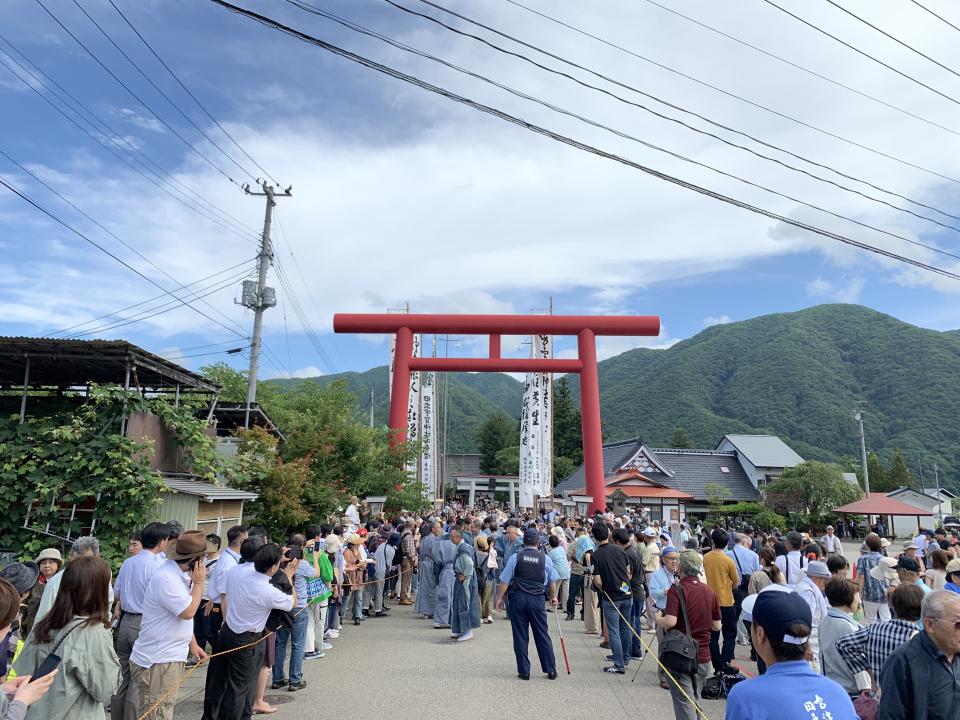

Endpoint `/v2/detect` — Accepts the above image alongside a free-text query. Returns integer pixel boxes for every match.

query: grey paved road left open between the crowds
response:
[177,605,755,720]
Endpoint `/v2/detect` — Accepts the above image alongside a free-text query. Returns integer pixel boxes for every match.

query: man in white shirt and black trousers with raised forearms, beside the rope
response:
[203,543,300,720]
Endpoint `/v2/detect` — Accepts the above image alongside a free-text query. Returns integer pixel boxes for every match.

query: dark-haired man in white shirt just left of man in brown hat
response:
[110,522,170,720]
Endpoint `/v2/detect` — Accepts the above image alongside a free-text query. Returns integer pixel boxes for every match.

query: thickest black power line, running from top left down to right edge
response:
[210,0,960,280]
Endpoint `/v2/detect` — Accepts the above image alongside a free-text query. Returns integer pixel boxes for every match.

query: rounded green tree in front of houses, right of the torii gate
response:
[764,460,862,525]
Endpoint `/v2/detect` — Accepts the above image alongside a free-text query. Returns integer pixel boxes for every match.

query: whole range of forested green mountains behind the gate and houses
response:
[270,305,960,488]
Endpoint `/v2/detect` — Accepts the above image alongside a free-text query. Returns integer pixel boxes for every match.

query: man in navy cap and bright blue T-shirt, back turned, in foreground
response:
[726,592,857,720]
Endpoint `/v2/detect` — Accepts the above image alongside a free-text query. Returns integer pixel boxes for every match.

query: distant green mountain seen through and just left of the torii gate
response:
[269,365,523,453]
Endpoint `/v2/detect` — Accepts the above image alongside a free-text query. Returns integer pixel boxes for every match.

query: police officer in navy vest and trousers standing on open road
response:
[497,528,560,680]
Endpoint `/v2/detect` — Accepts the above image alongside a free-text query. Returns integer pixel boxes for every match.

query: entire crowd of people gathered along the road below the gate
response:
[0,498,960,720]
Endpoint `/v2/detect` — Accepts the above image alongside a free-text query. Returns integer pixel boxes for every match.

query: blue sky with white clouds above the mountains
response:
[0,0,960,377]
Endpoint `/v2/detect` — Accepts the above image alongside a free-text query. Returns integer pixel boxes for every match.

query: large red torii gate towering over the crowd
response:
[333,313,660,511]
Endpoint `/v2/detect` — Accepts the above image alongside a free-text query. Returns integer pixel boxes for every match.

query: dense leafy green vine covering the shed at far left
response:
[0,387,169,566]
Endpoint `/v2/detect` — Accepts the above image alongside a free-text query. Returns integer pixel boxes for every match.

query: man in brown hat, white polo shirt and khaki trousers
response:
[130,526,207,720]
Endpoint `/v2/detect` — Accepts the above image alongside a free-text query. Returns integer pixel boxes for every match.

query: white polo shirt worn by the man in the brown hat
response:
[130,560,193,668]
